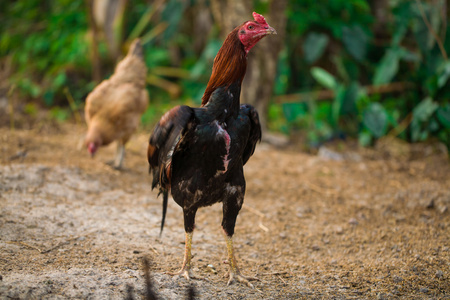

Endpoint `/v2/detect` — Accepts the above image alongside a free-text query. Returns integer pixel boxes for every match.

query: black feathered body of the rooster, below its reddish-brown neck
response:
[149,81,261,236]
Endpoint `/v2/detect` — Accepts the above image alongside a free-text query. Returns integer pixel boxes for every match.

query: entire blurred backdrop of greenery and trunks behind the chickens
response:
[0,0,450,148]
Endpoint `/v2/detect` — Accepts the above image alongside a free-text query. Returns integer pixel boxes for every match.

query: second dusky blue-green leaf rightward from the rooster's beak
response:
[342,25,369,61]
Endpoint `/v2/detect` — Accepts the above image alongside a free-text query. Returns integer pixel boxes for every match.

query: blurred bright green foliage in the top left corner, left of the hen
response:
[0,0,89,106]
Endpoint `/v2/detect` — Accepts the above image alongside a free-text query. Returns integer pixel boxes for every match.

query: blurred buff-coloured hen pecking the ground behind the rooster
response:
[85,39,148,169]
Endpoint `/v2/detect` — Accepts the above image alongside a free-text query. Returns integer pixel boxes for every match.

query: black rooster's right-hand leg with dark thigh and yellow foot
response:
[222,194,258,288]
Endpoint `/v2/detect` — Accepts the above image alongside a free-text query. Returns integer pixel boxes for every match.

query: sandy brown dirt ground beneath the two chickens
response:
[0,124,450,299]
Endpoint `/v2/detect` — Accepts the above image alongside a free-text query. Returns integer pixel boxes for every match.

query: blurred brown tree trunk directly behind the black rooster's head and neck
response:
[211,0,287,136]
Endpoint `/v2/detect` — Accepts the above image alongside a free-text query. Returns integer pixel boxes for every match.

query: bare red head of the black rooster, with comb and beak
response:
[238,12,277,53]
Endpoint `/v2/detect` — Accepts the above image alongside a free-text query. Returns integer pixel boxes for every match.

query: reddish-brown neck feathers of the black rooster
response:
[202,26,247,106]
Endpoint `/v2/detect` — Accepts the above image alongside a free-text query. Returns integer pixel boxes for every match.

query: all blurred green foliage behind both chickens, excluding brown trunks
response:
[0,0,450,151]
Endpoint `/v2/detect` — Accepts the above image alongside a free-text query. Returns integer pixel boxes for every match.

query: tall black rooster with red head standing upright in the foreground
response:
[148,12,276,287]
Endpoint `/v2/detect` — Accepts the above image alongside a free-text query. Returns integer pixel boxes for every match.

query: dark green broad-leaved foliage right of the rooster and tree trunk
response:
[283,0,450,147]
